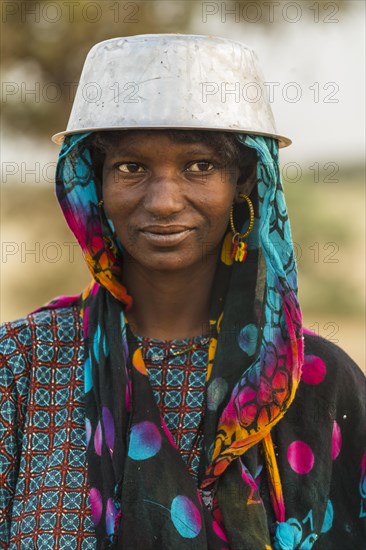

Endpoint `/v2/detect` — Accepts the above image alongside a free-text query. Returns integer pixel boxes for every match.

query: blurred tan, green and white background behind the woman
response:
[0,0,365,368]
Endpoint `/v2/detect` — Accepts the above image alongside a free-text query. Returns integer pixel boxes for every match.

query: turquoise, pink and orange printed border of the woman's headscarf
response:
[46,134,304,548]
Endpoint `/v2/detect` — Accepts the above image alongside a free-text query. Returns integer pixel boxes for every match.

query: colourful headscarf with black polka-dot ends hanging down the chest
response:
[56,134,303,550]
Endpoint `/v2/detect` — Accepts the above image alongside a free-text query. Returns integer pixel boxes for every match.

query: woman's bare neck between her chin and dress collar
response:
[124,256,216,340]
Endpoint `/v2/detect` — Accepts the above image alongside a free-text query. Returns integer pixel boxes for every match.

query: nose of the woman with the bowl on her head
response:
[144,170,184,218]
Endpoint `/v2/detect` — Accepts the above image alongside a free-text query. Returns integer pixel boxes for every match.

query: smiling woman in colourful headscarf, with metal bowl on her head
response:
[0,35,366,550]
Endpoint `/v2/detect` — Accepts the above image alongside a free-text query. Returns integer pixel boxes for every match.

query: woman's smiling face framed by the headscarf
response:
[103,131,242,271]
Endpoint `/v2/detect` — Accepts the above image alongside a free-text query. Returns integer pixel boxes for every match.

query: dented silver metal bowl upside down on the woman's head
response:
[52,34,291,147]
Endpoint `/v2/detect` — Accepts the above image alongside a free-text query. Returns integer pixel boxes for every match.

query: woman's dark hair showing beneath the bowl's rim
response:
[82,129,257,190]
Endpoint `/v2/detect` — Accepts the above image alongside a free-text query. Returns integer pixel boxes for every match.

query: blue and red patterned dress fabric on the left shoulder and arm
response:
[0,309,95,550]
